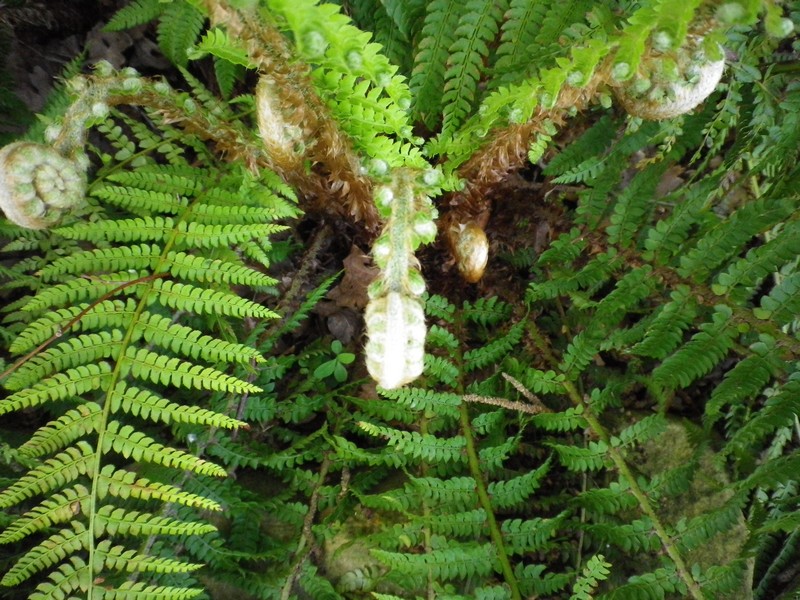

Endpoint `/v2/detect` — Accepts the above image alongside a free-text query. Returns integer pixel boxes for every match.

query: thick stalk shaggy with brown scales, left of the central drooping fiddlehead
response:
[197,0,379,232]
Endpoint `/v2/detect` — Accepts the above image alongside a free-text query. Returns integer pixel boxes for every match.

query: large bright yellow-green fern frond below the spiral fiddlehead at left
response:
[0,74,292,597]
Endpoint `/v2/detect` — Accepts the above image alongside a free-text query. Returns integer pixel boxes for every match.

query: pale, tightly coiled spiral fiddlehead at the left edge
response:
[0,142,86,229]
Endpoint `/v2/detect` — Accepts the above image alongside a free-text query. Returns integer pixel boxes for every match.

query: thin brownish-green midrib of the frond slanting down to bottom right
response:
[528,319,705,600]
